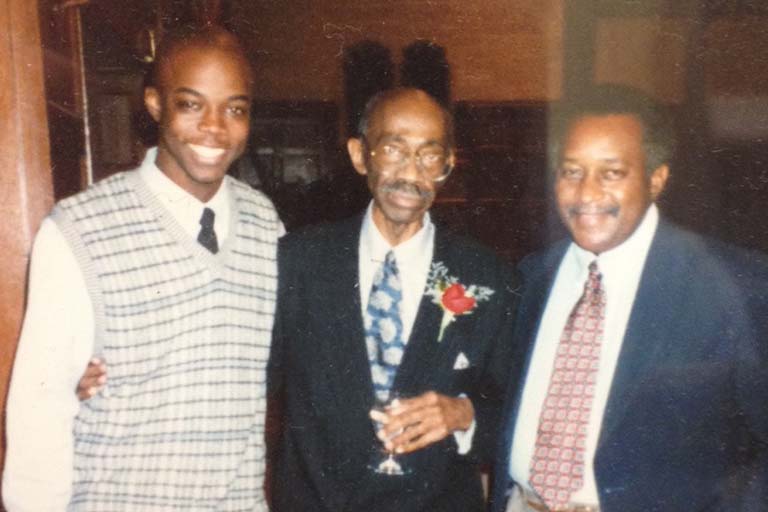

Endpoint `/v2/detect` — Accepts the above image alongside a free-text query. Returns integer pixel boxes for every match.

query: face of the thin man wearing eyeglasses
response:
[347,90,453,245]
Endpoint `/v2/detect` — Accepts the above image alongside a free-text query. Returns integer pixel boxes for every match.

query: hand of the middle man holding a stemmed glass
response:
[370,391,475,453]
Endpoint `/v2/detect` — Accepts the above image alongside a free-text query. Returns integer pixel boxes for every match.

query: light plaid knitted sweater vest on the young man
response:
[52,172,280,512]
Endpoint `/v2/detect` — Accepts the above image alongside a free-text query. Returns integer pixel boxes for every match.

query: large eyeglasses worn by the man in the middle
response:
[363,138,453,182]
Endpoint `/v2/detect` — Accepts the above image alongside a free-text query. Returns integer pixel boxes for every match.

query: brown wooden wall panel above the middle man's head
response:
[236,0,563,101]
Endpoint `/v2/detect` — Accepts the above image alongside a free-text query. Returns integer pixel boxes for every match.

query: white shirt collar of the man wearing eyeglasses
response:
[360,201,435,265]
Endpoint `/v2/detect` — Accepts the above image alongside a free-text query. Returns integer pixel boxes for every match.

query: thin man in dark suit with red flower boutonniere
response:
[268,89,516,512]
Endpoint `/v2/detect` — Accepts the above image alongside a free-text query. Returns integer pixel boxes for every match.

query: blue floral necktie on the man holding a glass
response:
[365,251,405,401]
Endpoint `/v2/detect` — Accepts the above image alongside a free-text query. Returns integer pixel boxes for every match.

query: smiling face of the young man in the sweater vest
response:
[144,44,251,202]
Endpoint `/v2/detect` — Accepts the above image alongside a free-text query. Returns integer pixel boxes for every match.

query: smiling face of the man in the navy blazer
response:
[555,114,669,254]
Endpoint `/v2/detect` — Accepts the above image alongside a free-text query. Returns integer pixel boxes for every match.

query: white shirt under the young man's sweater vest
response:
[3,149,236,512]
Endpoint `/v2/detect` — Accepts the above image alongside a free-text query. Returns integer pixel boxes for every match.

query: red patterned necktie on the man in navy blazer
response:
[530,261,605,510]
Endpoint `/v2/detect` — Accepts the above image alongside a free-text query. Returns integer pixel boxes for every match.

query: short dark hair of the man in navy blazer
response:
[549,84,677,175]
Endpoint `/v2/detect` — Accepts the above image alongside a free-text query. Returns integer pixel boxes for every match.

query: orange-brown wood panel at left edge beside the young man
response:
[0,0,52,484]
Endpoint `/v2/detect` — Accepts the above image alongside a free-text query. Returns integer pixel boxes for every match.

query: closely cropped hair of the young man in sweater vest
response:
[147,25,253,87]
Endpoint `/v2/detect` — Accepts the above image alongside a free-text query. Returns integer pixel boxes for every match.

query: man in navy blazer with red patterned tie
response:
[492,86,768,512]
